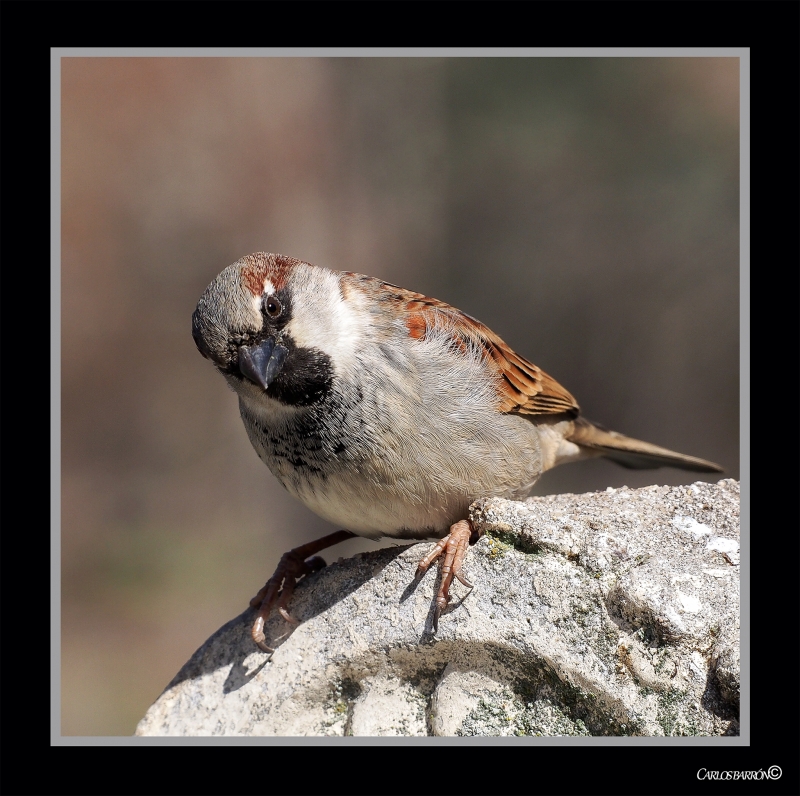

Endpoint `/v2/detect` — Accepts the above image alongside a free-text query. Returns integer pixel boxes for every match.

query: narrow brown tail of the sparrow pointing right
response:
[567,417,723,473]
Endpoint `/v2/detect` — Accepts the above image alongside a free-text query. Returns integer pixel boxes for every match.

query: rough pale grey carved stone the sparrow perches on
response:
[137,480,739,736]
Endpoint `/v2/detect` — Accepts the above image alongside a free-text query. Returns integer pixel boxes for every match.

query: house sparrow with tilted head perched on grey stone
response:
[192,252,722,652]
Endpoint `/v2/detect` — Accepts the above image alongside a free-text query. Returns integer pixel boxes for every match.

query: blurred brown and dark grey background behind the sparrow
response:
[61,58,739,735]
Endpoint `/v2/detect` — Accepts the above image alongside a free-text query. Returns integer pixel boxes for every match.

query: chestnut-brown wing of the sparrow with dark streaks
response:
[347,273,580,417]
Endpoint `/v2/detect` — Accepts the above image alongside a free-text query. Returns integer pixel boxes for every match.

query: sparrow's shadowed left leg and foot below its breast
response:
[250,531,355,655]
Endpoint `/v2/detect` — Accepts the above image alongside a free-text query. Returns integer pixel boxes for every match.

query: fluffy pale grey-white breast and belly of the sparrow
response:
[242,308,543,538]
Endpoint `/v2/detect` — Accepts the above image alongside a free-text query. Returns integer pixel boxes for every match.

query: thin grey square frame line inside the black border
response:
[50,47,751,746]
